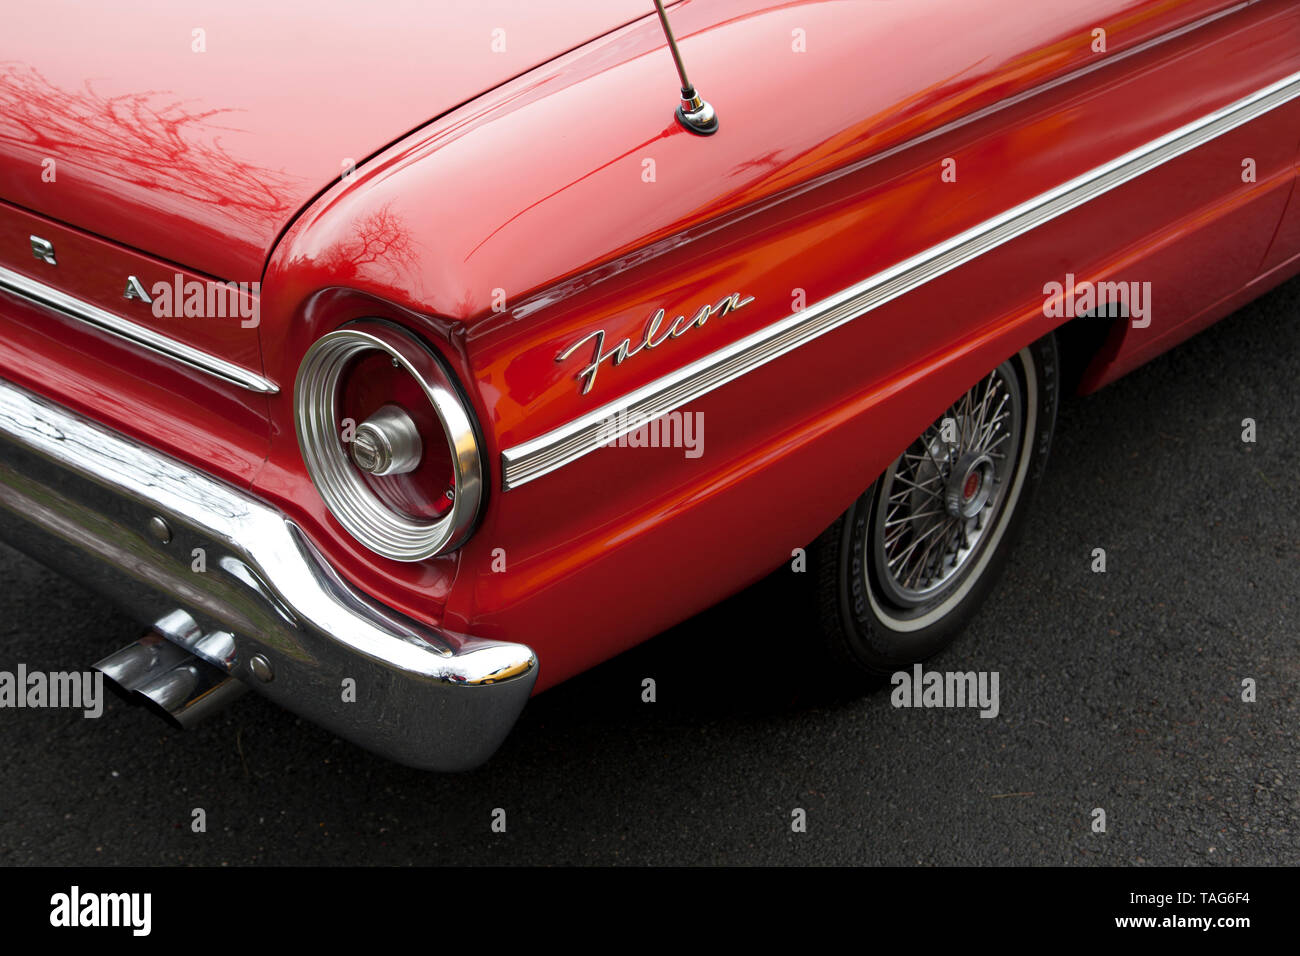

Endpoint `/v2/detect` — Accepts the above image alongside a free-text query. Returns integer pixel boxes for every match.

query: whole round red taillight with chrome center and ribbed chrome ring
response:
[294,321,482,561]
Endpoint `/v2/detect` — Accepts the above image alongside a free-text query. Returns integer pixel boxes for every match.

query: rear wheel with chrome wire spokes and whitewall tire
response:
[792,334,1061,689]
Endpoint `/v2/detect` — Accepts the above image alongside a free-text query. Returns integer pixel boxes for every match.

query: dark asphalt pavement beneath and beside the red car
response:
[0,274,1300,865]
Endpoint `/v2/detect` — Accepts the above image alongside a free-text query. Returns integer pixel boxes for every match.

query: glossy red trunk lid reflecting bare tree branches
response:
[0,0,651,282]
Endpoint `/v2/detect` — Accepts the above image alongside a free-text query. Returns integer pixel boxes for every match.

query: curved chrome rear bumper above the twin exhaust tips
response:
[0,380,537,770]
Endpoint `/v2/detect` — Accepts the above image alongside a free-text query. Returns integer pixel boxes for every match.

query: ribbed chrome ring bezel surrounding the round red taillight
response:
[294,320,484,562]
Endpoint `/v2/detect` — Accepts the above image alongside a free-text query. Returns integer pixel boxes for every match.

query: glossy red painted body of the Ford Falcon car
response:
[0,0,1300,766]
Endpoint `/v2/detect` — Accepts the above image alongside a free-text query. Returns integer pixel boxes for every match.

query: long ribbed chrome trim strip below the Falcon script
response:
[502,73,1300,490]
